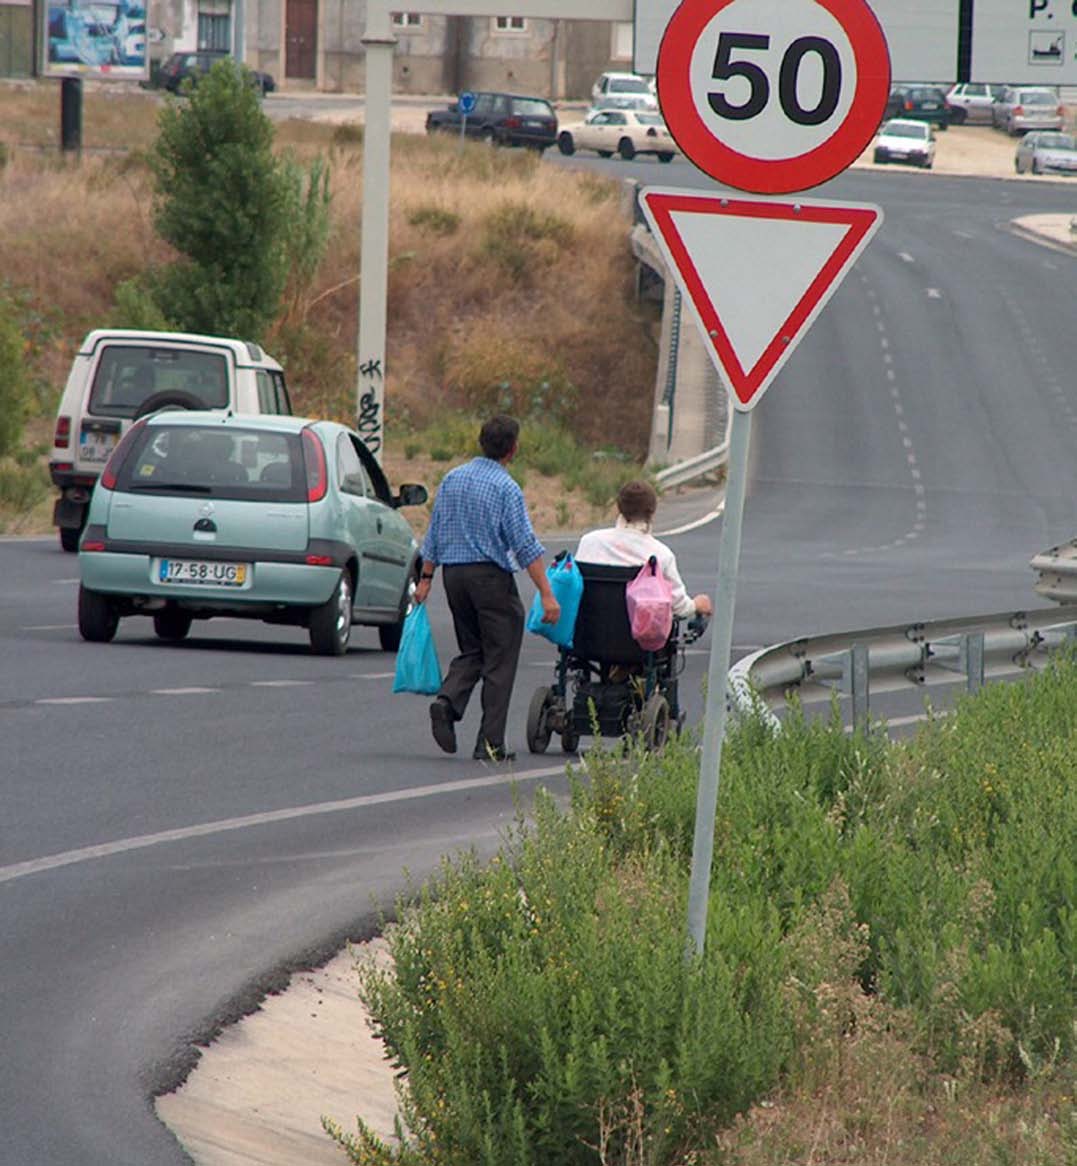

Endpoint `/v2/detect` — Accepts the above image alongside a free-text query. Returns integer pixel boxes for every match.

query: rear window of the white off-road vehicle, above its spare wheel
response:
[90,344,228,417]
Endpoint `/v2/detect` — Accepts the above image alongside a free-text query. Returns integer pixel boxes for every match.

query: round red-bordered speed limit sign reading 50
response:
[657,0,891,194]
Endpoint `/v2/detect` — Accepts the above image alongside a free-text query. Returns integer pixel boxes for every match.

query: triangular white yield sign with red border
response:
[640,188,882,410]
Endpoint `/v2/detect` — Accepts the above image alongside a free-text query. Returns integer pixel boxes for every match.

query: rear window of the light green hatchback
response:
[117,424,307,503]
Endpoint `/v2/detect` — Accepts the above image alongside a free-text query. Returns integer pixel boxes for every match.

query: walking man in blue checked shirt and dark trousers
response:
[415,414,561,761]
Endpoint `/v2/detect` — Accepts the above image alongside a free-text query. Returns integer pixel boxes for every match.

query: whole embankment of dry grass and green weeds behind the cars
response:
[0,82,657,533]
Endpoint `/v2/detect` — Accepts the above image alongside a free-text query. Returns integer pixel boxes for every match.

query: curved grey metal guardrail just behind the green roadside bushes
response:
[727,604,1077,725]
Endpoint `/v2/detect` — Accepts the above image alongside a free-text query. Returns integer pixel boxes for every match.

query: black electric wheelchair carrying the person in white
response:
[527,561,706,753]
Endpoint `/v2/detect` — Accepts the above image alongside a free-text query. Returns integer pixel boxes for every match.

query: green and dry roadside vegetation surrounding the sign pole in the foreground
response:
[324,658,1077,1166]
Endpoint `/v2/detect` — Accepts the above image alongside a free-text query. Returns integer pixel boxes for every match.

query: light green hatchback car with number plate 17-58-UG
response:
[78,412,427,655]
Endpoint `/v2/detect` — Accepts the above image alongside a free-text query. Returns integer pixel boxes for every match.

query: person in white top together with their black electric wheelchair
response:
[527,482,712,753]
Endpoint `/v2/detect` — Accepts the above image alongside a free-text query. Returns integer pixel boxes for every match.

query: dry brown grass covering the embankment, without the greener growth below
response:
[0,82,657,527]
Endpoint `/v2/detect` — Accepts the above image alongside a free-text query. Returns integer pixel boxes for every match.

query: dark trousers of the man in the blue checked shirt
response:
[438,563,523,749]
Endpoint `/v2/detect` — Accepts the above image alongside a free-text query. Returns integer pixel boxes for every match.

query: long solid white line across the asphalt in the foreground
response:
[0,760,568,883]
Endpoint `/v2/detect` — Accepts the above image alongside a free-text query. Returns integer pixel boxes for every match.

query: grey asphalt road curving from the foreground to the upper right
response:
[0,157,1077,1166]
